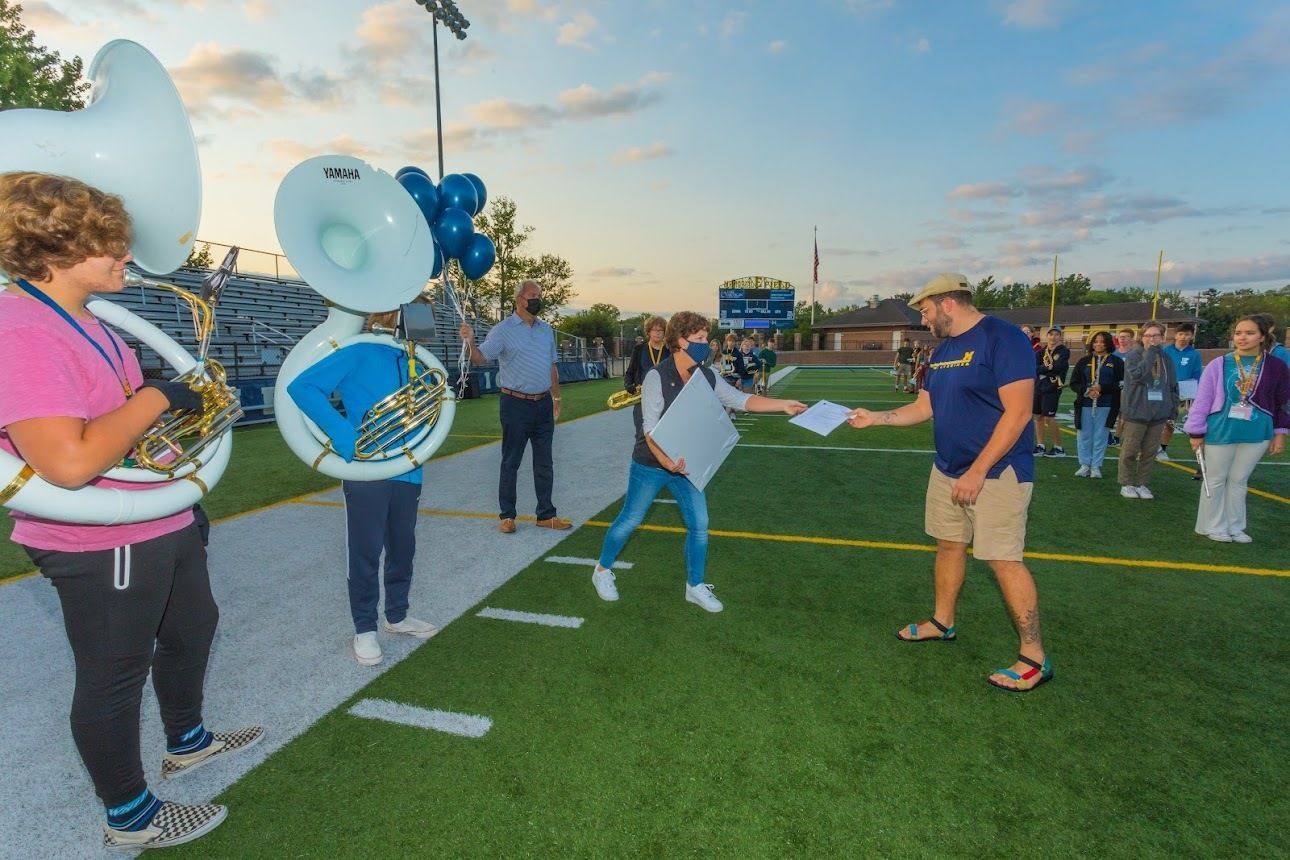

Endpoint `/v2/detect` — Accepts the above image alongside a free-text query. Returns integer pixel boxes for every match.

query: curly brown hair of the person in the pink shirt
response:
[0,173,132,281]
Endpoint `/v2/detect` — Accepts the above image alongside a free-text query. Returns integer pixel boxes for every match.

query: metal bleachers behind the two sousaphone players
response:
[103,268,489,420]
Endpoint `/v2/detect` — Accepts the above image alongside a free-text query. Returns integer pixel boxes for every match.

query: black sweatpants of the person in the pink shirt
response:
[26,525,219,807]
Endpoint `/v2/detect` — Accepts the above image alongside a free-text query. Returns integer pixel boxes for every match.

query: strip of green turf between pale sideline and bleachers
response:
[0,379,622,581]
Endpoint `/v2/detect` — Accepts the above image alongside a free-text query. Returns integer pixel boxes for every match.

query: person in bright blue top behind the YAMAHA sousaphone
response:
[286,305,439,665]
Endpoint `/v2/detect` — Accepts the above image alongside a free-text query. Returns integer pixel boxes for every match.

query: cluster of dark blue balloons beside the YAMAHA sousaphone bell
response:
[395,166,497,281]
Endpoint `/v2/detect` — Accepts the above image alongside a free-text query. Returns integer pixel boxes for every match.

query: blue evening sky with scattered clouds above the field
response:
[22,0,1290,311]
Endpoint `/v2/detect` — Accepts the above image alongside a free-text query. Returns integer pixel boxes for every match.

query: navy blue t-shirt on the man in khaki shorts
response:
[926,316,1035,484]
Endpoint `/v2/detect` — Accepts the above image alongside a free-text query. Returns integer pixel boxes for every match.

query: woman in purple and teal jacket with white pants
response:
[1183,315,1290,544]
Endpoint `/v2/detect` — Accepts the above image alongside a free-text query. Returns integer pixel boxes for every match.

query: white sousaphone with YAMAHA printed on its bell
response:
[273,155,457,481]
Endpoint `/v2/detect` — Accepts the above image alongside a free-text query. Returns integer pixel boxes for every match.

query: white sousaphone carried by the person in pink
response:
[0,40,241,525]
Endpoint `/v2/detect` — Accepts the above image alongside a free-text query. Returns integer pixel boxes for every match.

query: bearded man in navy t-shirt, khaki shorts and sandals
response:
[850,275,1053,692]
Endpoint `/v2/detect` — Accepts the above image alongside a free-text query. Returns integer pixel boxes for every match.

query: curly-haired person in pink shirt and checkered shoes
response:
[0,173,263,848]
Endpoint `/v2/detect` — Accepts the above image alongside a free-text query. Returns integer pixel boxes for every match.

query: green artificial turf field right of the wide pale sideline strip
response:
[163,371,1290,857]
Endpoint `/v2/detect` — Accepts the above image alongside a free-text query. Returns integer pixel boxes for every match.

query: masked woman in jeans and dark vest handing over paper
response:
[591,311,806,612]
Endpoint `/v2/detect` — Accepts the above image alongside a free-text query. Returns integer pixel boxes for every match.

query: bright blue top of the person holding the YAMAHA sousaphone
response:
[286,343,421,484]
